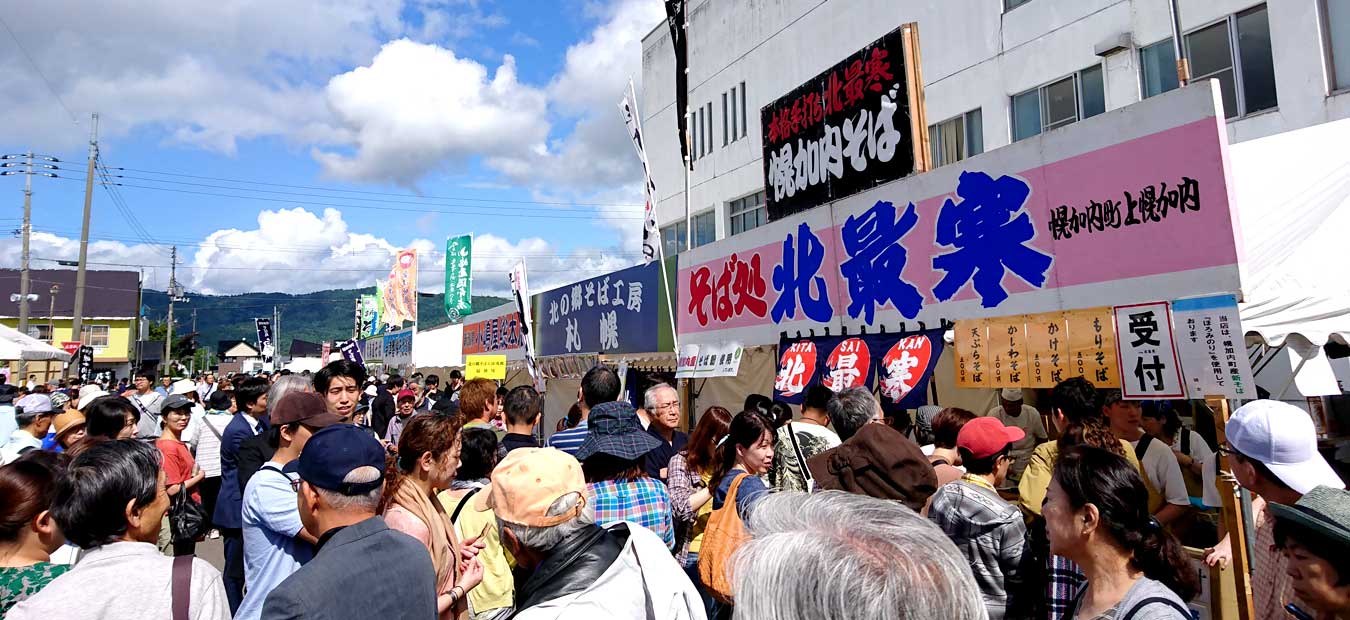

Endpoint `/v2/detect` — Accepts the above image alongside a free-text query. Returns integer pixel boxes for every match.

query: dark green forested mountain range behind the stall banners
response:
[142,288,510,353]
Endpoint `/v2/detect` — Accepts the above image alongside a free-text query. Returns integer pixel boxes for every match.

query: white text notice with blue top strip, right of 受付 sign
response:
[1172,294,1257,398]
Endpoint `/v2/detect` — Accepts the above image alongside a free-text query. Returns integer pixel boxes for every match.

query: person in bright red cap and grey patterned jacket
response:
[929,417,1031,620]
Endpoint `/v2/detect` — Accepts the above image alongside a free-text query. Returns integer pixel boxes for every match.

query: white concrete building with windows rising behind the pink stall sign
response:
[641,0,1350,255]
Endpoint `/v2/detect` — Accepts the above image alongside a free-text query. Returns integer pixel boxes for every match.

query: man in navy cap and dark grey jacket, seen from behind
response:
[262,424,434,620]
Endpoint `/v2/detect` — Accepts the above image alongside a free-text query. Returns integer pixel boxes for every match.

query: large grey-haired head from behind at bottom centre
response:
[732,490,987,620]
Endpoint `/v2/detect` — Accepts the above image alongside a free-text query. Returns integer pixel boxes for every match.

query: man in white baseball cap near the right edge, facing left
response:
[1204,400,1346,617]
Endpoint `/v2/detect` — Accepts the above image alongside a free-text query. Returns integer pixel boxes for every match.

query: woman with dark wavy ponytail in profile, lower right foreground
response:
[1045,446,1197,620]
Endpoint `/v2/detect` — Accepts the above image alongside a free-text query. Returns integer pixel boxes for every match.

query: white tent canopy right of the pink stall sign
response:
[1229,119,1350,350]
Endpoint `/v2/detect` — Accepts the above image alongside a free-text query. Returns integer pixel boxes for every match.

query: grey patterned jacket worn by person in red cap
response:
[929,475,1031,620]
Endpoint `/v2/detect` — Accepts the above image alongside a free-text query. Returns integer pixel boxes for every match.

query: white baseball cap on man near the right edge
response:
[1224,400,1346,493]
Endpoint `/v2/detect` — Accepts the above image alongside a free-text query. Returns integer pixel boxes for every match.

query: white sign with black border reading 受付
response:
[1112,301,1185,398]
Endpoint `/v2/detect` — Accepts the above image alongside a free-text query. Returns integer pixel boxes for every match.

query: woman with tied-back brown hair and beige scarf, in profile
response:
[381,413,483,620]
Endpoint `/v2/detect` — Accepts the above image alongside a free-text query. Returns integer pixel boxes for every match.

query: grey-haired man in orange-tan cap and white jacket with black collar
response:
[474,448,705,620]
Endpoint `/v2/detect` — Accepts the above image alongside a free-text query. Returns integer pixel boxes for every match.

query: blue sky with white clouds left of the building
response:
[0,0,663,293]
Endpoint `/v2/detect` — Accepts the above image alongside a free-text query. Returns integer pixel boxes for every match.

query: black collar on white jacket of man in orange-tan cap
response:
[516,523,628,612]
